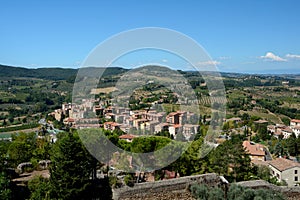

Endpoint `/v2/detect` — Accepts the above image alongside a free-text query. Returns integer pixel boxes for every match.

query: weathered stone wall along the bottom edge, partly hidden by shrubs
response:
[113,173,300,200]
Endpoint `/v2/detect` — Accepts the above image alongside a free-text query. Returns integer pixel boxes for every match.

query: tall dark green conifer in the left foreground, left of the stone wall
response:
[50,133,92,199]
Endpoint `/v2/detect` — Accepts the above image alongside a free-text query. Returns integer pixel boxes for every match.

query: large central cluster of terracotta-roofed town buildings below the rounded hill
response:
[50,99,199,140]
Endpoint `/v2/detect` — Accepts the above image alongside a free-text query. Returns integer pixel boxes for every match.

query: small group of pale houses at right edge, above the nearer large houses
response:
[267,119,300,139]
